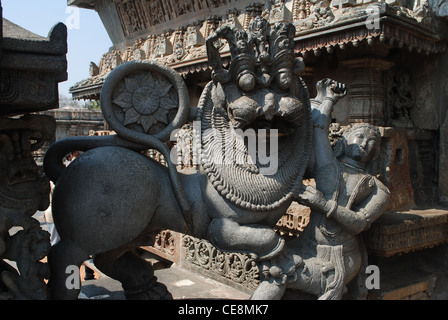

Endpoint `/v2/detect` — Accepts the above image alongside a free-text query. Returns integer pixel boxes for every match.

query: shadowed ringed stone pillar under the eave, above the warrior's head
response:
[342,57,393,126]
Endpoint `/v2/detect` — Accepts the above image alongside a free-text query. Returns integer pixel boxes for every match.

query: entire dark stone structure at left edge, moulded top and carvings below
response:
[0,6,67,300]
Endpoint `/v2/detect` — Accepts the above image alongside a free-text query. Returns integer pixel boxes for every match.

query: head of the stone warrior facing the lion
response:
[344,123,381,165]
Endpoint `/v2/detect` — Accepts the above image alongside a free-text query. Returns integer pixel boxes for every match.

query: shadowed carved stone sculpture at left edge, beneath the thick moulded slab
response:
[0,115,55,299]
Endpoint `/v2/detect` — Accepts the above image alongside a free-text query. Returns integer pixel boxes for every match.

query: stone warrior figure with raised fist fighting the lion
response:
[252,79,390,299]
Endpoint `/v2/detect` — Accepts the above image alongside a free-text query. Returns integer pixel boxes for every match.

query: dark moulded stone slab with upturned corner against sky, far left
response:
[0,19,67,115]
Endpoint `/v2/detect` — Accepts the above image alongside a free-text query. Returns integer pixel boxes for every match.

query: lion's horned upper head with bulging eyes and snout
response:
[207,17,309,135]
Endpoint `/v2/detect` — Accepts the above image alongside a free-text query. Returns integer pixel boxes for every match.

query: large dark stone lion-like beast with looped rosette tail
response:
[44,18,383,299]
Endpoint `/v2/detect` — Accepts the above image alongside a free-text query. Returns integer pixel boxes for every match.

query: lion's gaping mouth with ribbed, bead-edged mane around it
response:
[197,77,312,212]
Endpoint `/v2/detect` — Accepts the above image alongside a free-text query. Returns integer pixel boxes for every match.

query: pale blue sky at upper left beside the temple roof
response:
[1,0,112,96]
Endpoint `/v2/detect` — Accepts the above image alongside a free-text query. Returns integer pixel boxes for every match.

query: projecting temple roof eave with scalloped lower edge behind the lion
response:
[70,6,446,99]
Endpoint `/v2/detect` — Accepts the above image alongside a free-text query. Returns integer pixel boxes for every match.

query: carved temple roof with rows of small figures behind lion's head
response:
[71,0,444,98]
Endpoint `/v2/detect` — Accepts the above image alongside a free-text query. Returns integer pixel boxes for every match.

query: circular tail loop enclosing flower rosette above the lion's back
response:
[101,61,190,141]
